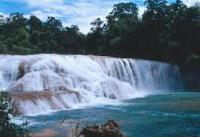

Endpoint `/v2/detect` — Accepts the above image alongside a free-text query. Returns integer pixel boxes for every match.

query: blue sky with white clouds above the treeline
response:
[0,0,200,33]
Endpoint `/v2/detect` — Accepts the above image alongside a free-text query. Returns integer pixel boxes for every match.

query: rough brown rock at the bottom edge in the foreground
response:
[79,120,123,137]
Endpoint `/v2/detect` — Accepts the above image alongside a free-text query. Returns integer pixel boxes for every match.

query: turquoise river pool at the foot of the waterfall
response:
[18,92,200,137]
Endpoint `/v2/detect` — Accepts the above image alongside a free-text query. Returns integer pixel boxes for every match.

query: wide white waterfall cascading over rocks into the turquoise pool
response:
[0,55,181,114]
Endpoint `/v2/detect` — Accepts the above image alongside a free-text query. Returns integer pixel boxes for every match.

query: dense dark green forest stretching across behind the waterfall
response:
[0,0,200,64]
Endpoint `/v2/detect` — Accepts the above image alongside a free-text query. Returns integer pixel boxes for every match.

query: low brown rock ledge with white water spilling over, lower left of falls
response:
[9,90,80,115]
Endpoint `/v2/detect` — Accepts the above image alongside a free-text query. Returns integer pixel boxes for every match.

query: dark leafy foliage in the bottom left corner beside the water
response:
[0,92,28,137]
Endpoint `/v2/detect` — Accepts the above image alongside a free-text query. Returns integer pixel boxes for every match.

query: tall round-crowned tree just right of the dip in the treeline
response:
[106,2,139,55]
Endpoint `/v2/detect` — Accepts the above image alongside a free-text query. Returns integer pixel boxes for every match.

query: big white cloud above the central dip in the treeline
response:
[18,0,129,33]
